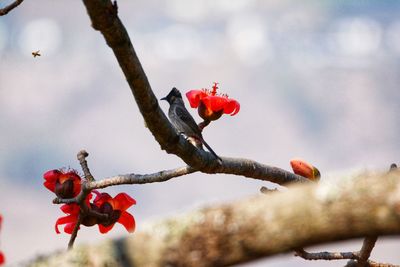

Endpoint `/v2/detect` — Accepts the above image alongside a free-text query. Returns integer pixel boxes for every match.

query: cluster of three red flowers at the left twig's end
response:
[43,170,136,234]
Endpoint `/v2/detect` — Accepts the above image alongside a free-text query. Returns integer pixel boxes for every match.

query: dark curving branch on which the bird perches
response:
[78,0,306,184]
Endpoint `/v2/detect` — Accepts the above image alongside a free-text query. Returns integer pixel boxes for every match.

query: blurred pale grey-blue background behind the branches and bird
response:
[0,0,400,266]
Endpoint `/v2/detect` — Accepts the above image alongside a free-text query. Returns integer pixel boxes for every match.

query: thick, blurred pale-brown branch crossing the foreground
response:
[27,171,400,266]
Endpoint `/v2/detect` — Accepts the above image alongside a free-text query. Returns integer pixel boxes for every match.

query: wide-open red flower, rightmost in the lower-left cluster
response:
[93,193,136,234]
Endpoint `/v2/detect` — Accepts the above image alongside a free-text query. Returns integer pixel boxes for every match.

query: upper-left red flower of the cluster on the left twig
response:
[43,170,81,198]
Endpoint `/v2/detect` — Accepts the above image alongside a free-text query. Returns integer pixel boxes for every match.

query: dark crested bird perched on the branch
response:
[160,87,222,161]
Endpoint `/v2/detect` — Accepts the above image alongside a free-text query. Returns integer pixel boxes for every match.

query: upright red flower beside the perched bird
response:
[186,83,240,121]
